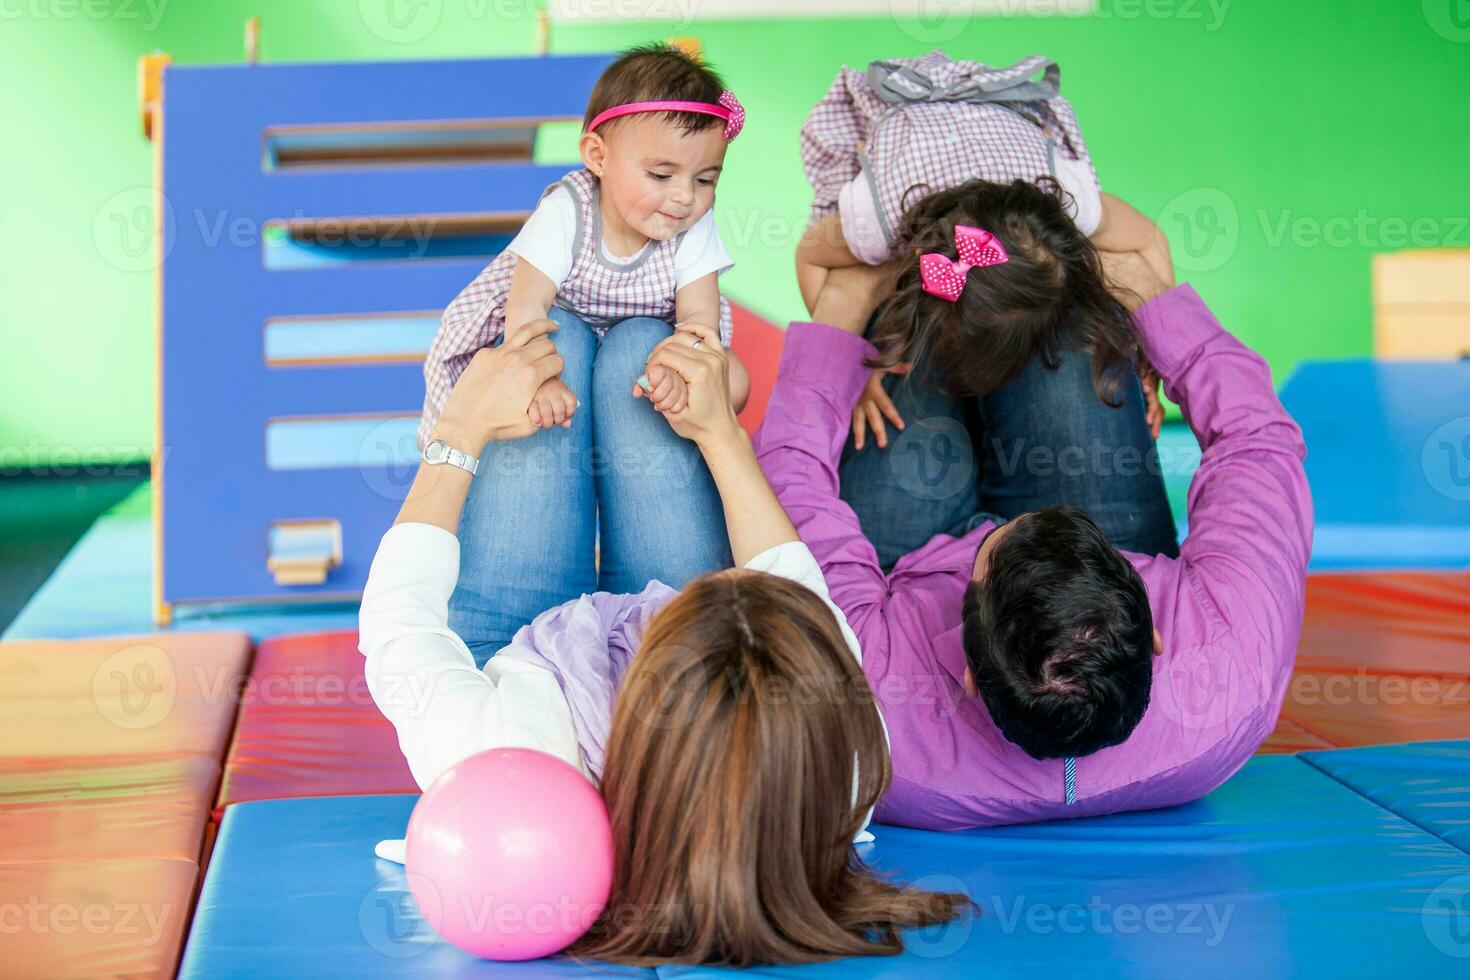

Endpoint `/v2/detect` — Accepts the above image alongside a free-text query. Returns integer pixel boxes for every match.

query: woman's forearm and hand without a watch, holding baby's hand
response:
[648,323,800,566]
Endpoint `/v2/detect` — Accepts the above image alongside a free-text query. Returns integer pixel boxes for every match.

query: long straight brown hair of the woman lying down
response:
[572,570,969,967]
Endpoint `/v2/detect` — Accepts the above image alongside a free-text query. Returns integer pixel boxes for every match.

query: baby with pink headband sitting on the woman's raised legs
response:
[419,44,750,445]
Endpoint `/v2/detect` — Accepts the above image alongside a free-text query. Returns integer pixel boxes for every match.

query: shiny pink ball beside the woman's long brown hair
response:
[404,749,613,959]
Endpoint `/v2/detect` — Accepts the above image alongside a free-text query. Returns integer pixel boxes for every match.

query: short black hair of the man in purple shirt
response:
[964,507,1154,758]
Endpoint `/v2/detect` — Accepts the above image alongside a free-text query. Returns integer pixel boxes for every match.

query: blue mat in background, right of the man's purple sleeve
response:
[1282,360,1470,569]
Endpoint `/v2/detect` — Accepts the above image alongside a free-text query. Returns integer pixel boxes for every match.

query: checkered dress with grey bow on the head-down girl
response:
[801,51,1097,245]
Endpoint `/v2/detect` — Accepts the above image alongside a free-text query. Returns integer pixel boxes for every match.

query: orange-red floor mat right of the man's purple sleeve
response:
[1261,572,1470,752]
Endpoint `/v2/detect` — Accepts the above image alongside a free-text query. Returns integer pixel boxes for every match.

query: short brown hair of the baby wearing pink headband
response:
[582,44,725,132]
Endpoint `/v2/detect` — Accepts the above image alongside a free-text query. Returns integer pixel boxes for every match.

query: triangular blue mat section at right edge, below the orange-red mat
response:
[1302,742,1470,852]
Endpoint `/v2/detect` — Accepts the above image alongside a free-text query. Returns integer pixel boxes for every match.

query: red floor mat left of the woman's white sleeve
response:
[216,630,419,814]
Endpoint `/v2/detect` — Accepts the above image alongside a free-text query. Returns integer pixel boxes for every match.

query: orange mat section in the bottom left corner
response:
[0,861,198,980]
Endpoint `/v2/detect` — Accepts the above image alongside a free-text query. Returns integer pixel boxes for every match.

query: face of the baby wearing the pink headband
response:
[594,113,726,241]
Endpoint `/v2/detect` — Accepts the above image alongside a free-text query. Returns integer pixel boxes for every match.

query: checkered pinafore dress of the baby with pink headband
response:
[419,170,731,447]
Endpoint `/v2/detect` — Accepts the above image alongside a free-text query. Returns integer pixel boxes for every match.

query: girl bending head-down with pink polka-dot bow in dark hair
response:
[797,51,1173,448]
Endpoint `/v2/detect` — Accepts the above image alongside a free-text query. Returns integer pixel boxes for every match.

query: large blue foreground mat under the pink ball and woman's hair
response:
[181,757,1470,980]
